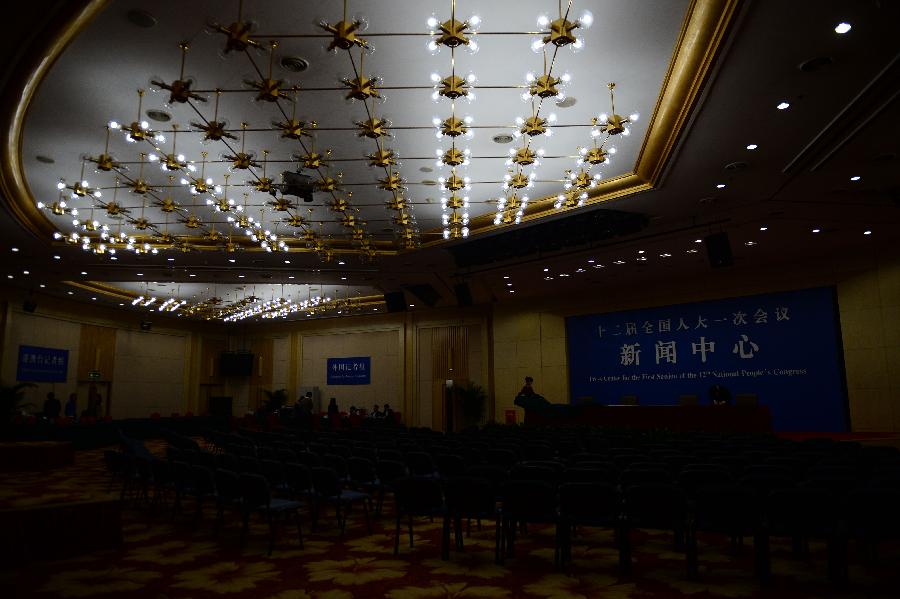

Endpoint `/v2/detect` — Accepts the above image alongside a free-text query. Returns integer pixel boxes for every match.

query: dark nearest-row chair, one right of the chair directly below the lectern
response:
[559,482,631,572]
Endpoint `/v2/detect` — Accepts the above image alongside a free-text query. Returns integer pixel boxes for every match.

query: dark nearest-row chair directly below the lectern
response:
[499,480,560,565]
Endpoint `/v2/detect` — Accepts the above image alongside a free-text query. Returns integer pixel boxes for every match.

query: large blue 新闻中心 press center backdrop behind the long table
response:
[566,287,847,431]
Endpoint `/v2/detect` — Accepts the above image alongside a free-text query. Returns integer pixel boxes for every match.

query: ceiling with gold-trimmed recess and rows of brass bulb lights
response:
[4,0,900,326]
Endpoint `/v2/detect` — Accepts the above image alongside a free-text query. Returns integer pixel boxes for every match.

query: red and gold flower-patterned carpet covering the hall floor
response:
[0,446,900,599]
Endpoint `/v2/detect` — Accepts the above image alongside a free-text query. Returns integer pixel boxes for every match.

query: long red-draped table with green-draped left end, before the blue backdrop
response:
[513,394,772,433]
